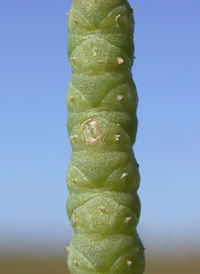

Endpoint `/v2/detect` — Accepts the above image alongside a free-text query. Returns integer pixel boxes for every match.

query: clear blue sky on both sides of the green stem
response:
[0,0,200,256]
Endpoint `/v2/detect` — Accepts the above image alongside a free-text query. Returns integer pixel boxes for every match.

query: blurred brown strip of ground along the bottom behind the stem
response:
[0,250,200,274]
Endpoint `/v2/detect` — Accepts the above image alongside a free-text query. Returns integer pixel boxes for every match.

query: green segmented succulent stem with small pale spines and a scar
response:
[66,0,145,274]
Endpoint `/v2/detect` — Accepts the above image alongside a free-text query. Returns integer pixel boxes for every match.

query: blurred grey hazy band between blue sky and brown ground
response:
[0,224,200,260]
